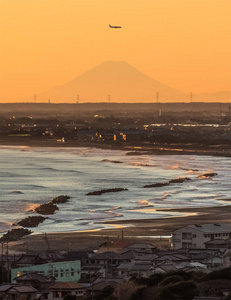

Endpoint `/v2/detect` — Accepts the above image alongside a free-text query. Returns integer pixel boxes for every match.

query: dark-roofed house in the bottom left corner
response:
[0,283,38,300]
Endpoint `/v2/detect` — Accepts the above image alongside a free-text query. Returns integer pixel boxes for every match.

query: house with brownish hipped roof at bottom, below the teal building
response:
[47,281,86,300]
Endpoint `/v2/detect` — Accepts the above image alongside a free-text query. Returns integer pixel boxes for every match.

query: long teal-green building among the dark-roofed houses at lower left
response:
[11,260,81,282]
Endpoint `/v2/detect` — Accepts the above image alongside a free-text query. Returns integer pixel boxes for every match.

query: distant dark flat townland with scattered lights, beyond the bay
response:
[0,103,231,156]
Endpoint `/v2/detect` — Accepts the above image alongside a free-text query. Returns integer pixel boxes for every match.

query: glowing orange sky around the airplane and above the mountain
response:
[0,0,231,102]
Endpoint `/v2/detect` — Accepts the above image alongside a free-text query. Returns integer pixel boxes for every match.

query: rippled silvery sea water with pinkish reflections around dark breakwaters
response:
[0,146,231,234]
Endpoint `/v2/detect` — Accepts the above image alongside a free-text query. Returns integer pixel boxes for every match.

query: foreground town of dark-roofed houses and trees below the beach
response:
[0,223,231,300]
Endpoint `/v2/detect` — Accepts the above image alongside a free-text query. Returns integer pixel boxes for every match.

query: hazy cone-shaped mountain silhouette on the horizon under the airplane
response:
[38,61,231,103]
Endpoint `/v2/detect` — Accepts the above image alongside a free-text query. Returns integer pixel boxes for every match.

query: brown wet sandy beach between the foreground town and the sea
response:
[9,205,231,253]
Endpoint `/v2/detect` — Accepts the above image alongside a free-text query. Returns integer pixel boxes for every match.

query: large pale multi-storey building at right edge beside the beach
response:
[171,223,231,250]
